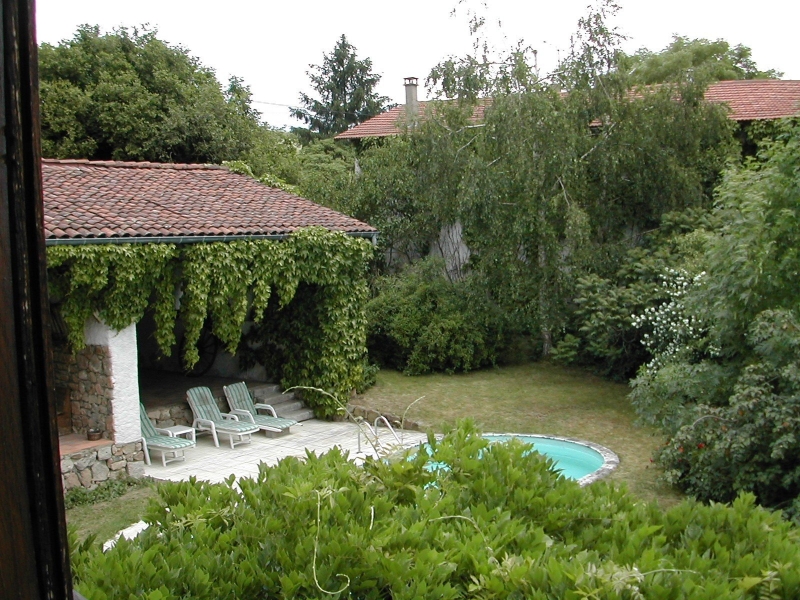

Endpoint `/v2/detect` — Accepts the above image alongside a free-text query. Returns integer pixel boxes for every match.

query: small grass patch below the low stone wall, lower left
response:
[67,484,158,543]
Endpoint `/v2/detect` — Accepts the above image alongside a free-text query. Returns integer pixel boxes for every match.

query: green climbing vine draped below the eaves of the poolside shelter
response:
[48,227,372,416]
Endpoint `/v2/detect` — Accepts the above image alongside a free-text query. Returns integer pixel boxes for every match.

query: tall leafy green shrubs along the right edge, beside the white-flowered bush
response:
[632,124,800,505]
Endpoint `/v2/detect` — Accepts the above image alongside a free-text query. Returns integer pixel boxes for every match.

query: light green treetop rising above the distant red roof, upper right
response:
[626,35,783,85]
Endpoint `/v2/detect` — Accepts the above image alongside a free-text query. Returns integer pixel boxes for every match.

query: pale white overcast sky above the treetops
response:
[36,0,800,127]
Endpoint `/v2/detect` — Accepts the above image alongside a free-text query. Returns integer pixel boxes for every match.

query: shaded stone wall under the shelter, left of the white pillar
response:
[53,345,114,439]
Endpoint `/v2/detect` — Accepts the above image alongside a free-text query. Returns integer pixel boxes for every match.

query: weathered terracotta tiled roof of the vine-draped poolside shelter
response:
[42,159,377,244]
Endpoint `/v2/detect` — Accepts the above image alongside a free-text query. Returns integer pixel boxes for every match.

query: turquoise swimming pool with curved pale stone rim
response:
[418,433,619,486]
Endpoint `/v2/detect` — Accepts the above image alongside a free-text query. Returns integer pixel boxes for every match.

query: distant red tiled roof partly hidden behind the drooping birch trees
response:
[335,79,800,140]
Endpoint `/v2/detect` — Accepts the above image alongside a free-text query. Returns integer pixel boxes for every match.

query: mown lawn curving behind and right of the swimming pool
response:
[354,363,682,508]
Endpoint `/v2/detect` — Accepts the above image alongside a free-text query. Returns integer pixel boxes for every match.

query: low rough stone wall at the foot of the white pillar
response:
[61,442,144,491]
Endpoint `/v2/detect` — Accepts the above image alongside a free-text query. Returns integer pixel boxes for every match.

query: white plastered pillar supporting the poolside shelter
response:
[84,318,142,444]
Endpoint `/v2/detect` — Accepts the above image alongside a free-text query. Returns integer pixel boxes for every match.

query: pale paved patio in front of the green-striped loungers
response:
[145,419,427,483]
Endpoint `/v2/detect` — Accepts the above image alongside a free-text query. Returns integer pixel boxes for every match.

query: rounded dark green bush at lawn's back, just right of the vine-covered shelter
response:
[367,260,506,375]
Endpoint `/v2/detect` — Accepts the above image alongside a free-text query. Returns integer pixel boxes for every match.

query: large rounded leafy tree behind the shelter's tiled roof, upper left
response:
[39,26,258,163]
